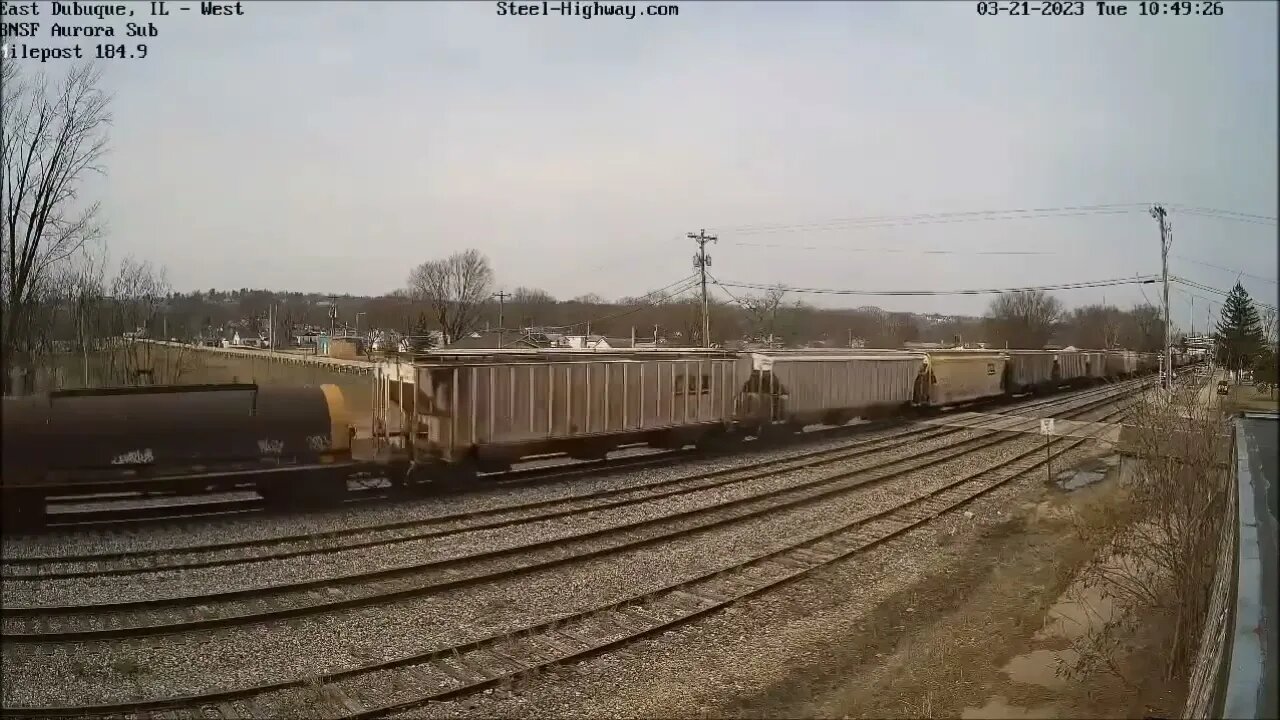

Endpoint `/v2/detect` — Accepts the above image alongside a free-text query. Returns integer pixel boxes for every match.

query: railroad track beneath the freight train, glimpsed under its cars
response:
[15,376,1121,534]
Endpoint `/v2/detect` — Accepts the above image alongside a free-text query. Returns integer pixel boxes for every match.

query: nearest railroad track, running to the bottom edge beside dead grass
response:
[5,379,1128,719]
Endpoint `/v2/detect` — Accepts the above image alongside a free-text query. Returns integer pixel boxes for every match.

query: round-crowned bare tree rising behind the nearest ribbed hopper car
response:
[408,250,493,343]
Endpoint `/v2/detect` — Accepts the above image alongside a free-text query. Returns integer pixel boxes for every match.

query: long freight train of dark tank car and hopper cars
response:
[0,350,1185,519]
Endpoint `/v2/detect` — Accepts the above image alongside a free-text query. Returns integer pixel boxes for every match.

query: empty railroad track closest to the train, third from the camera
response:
[4,379,1136,580]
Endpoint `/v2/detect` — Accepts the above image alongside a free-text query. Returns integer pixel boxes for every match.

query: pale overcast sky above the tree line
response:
[10,0,1277,327]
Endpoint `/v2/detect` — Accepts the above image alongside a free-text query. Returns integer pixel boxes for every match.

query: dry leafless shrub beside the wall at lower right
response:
[1059,386,1231,685]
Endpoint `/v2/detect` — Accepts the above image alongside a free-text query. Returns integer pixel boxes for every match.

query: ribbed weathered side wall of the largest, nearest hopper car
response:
[417,357,741,457]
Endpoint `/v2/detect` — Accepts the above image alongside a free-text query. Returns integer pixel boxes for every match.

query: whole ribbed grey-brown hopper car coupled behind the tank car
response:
[394,352,746,471]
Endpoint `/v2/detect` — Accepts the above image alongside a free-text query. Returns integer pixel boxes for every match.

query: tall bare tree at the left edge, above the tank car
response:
[0,61,111,386]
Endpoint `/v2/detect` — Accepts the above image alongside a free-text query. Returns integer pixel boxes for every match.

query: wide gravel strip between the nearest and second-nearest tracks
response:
[4,420,1064,705]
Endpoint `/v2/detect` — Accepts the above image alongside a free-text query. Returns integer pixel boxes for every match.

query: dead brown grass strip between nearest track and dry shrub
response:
[718,453,1180,717]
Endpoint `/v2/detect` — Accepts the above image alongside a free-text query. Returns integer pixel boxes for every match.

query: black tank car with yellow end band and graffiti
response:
[3,383,353,520]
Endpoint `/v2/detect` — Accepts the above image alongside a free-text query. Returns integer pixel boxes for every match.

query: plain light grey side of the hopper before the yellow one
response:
[753,352,924,420]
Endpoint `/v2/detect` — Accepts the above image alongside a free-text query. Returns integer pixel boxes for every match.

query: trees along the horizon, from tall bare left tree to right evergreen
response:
[0,63,1275,392]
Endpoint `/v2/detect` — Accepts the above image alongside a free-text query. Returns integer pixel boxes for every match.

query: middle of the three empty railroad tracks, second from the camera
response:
[3,379,1128,643]
